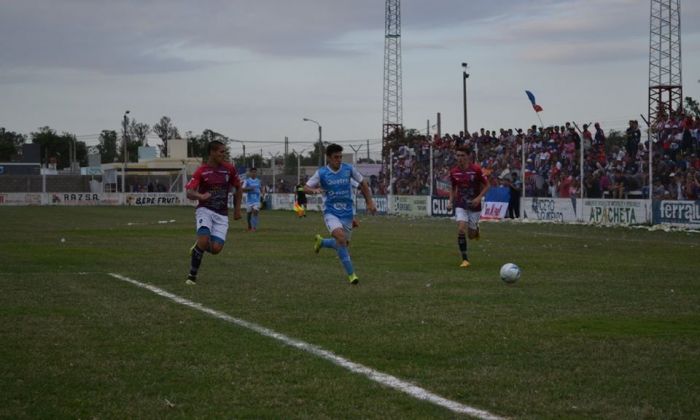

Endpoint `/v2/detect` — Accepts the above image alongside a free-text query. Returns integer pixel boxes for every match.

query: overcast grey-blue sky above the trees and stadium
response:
[0,0,700,155]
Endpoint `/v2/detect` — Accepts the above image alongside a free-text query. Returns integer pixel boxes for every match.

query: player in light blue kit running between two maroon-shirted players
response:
[304,144,377,284]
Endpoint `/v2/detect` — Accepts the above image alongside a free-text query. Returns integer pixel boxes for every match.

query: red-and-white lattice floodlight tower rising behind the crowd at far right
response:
[648,0,683,128]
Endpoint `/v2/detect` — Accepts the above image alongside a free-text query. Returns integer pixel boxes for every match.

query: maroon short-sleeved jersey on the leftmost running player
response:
[185,162,241,215]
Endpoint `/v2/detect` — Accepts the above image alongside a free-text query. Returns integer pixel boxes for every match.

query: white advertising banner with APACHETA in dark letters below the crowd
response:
[583,199,650,225]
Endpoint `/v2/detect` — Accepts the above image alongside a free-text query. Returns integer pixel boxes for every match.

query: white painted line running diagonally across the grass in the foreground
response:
[109,273,504,420]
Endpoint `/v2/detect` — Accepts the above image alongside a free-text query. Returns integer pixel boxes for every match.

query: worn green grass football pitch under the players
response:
[0,207,700,419]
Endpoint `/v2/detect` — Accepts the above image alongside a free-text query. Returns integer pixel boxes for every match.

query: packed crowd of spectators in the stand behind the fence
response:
[376,116,700,200]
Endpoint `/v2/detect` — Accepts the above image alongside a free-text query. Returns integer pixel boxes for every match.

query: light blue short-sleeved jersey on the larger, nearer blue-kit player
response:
[306,163,362,219]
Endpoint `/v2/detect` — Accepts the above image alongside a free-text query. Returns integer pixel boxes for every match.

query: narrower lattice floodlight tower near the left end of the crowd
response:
[382,0,403,163]
